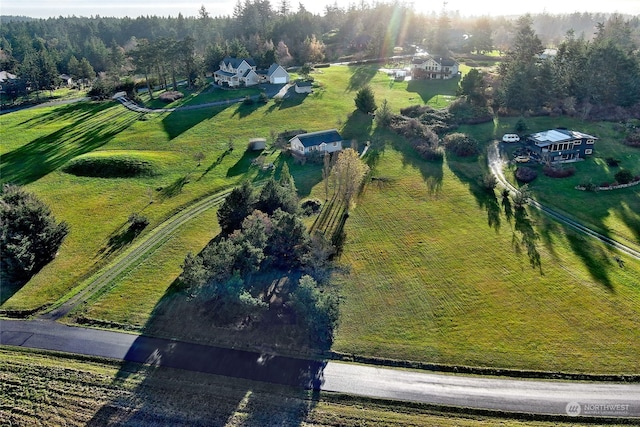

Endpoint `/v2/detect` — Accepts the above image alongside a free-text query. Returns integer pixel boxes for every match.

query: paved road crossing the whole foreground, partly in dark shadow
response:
[0,320,640,418]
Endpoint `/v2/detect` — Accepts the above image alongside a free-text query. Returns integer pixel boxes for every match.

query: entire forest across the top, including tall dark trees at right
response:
[0,0,640,110]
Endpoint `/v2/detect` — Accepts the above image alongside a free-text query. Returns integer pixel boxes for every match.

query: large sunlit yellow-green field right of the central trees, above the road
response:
[334,147,640,373]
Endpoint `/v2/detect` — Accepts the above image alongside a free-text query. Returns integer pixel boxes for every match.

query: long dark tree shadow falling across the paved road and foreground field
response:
[88,270,326,426]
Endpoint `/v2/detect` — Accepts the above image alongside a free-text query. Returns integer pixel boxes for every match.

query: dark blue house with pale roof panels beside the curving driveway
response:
[526,129,598,163]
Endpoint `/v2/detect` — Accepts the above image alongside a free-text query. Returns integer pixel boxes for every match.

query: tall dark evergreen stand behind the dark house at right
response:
[460,15,640,119]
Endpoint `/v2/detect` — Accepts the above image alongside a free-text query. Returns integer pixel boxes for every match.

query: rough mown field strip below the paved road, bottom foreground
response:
[0,349,624,427]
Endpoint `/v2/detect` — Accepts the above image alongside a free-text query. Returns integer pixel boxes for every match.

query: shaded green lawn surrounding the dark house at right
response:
[461,117,640,250]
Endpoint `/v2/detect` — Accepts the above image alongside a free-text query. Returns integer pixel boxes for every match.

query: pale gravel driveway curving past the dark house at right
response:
[488,141,640,259]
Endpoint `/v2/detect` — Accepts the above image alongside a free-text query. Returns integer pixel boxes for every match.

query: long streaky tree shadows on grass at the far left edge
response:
[0,108,138,185]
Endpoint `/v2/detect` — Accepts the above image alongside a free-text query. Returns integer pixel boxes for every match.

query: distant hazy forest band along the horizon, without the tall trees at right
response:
[0,0,640,100]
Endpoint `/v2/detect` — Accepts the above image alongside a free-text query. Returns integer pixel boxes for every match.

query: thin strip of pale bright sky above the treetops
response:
[0,0,640,18]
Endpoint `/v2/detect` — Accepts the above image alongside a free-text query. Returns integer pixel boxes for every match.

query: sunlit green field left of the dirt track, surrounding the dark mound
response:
[0,63,436,311]
